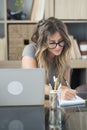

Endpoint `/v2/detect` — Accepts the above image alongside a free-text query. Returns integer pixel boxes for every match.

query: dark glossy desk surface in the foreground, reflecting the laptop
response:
[0,93,87,130]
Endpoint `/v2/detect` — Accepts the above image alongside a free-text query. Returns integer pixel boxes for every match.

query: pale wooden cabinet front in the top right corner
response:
[54,0,87,20]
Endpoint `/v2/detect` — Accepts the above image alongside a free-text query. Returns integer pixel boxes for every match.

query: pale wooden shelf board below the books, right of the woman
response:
[70,59,87,69]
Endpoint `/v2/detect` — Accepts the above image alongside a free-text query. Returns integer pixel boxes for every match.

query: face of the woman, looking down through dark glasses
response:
[48,32,65,58]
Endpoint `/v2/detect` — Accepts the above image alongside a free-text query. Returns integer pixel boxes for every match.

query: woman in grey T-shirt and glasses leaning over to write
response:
[22,17,76,99]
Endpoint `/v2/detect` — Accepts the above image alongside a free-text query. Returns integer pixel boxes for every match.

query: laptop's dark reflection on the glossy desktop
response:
[0,106,45,130]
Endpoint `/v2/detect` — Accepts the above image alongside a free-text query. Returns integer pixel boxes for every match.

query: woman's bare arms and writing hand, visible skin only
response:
[22,56,76,100]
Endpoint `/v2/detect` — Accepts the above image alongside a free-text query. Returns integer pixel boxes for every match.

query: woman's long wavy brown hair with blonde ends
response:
[31,17,71,82]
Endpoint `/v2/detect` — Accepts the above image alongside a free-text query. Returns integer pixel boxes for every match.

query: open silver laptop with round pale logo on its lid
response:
[0,68,45,106]
